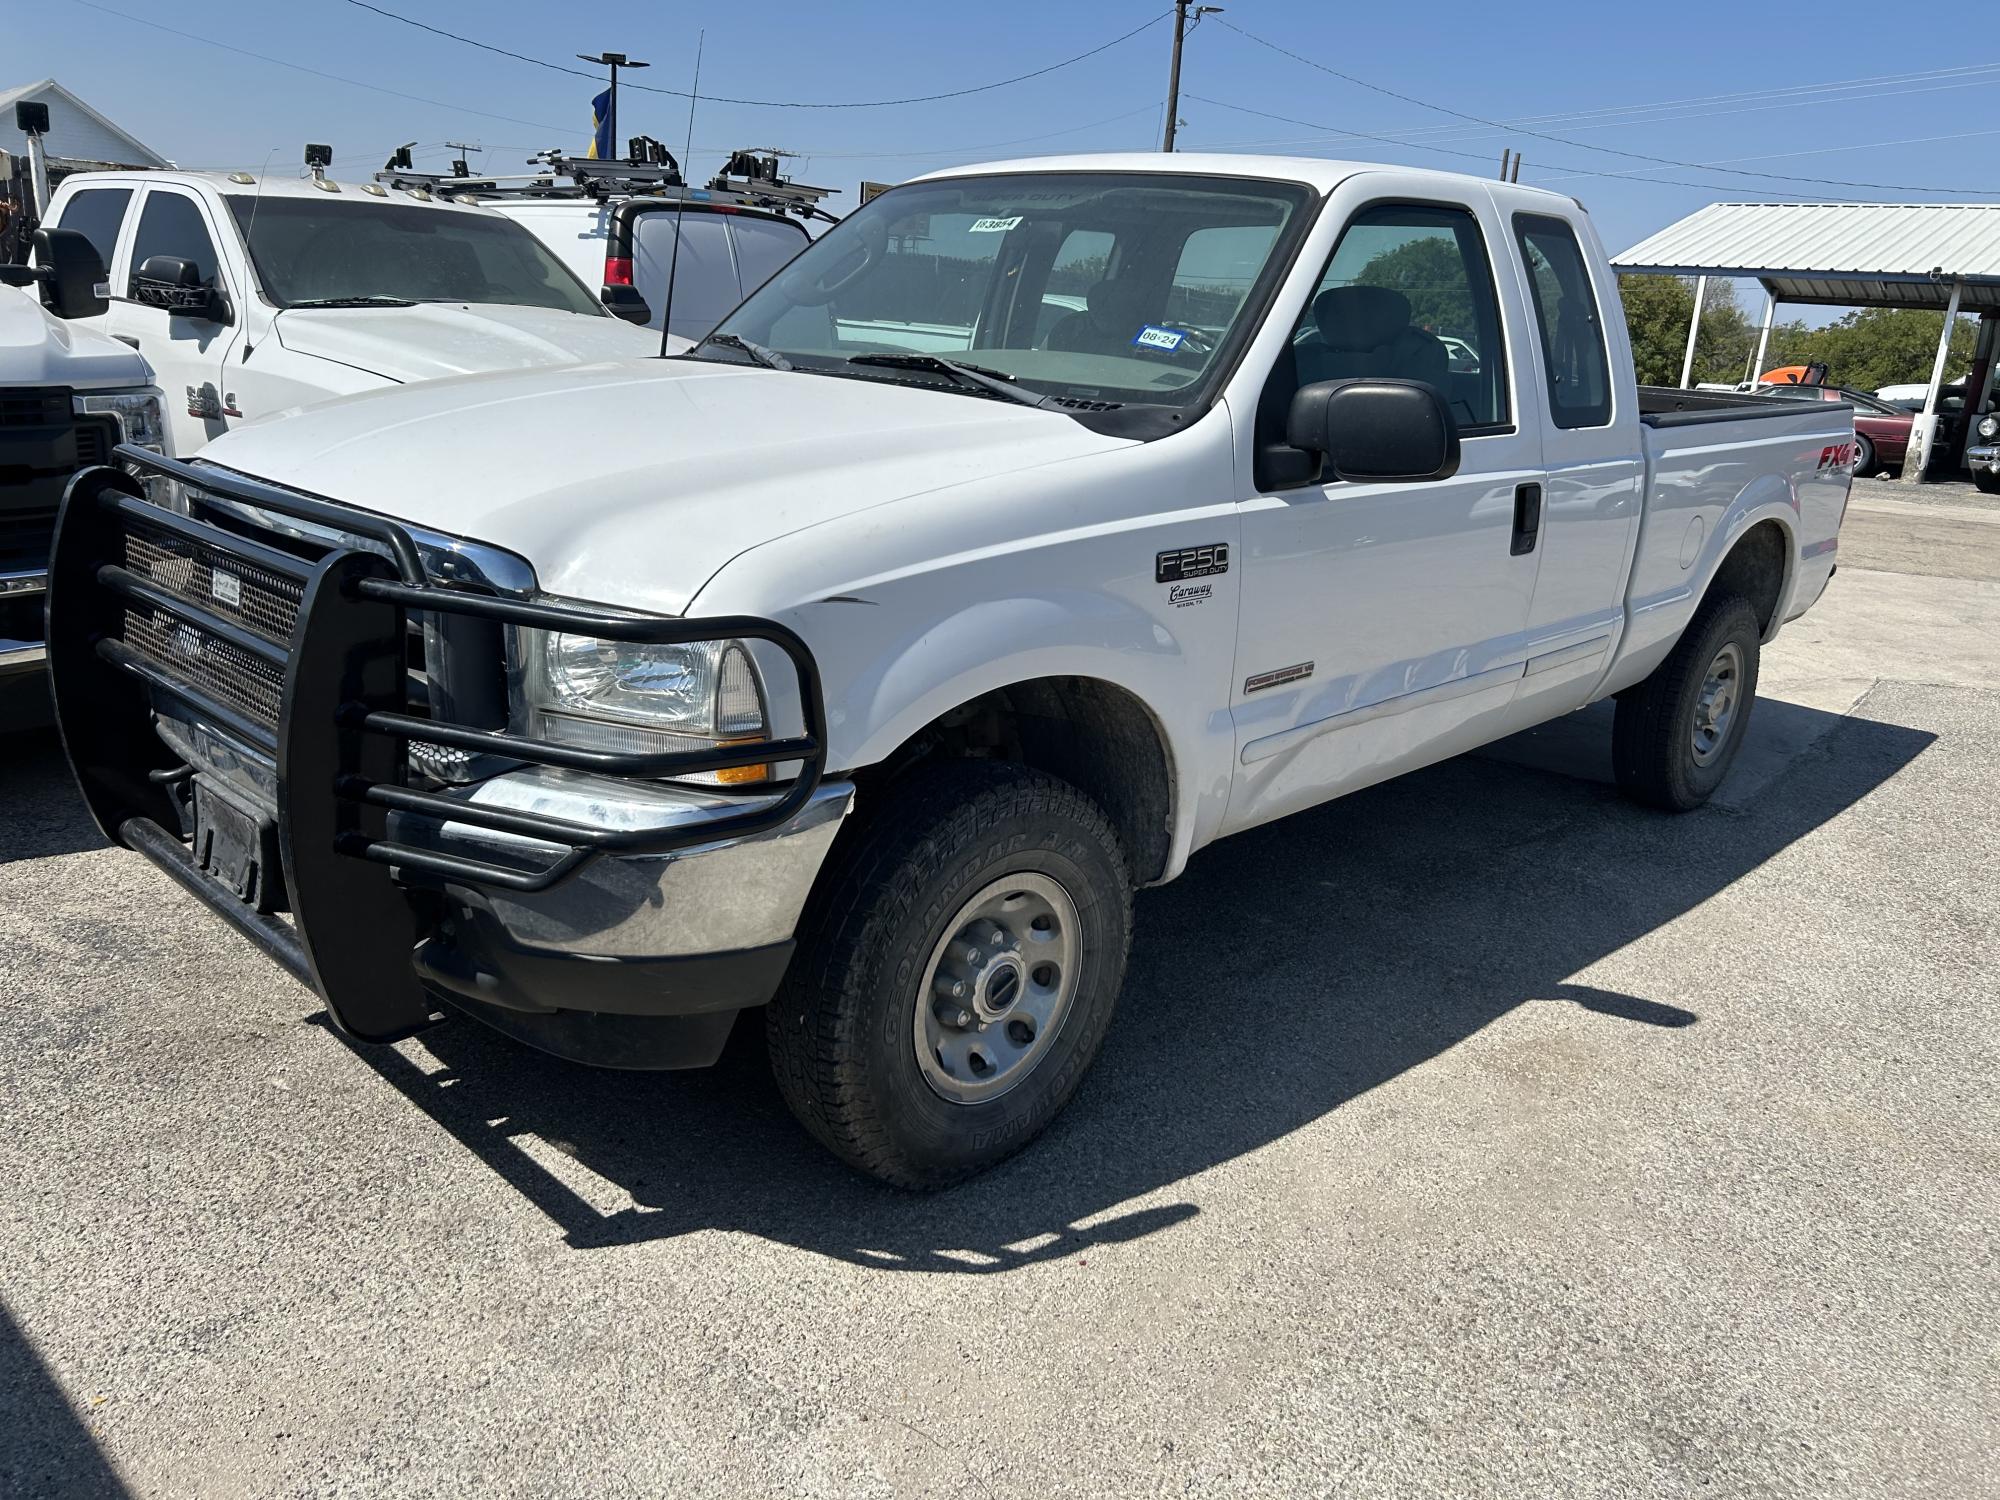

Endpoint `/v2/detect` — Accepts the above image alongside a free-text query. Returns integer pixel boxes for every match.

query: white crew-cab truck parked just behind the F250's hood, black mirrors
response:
[46,172,660,454]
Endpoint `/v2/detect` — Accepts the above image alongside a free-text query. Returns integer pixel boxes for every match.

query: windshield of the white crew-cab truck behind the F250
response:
[230,194,604,316]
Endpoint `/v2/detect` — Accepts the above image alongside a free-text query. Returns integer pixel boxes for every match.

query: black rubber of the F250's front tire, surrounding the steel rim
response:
[766,762,1132,1188]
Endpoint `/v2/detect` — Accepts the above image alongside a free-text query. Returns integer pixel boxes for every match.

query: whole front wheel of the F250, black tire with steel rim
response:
[766,760,1132,1190]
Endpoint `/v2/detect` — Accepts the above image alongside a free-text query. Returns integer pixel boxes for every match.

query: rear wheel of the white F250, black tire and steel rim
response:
[1612,594,1762,812]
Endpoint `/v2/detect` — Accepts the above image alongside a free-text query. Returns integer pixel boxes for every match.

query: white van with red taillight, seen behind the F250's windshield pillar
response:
[490,196,812,352]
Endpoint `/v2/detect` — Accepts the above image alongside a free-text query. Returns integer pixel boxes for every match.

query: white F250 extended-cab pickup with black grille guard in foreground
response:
[50,156,1854,1188]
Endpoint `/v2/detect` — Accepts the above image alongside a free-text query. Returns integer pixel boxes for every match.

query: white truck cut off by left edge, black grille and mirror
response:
[0,230,172,734]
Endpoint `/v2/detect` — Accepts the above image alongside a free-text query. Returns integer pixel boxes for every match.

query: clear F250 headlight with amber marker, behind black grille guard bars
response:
[522,630,770,784]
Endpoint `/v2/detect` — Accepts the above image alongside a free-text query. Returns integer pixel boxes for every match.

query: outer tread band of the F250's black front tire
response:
[766,760,1132,1190]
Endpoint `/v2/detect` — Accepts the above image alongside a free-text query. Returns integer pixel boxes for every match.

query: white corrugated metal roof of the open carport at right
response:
[1612,204,2000,312]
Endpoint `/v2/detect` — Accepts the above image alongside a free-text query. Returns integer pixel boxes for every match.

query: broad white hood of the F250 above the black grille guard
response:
[202,360,1130,614]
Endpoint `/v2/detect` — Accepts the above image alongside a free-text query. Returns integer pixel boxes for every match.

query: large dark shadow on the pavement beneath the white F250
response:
[324,700,1934,1274]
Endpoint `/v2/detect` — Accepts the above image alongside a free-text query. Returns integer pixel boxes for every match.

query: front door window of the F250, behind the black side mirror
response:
[1292,204,1508,432]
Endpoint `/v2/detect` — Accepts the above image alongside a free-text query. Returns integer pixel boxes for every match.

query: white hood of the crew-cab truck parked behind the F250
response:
[272,302,686,384]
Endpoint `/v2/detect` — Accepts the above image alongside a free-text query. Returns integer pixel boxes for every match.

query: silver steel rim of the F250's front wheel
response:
[912,872,1082,1104]
